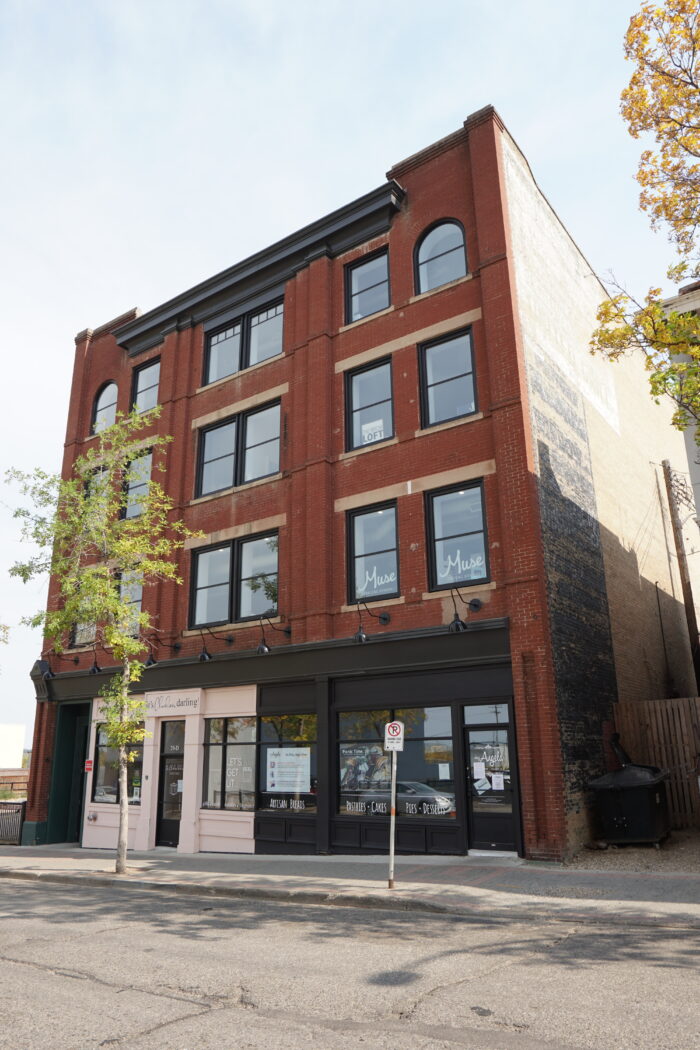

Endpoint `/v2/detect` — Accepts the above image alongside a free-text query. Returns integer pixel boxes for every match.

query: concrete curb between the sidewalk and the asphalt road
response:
[0,870,700,930]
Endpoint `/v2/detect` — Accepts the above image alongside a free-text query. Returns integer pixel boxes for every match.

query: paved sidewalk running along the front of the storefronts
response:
[0,845,700,929]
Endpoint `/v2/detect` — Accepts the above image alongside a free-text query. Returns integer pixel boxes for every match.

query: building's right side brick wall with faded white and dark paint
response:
[503,127,693,841]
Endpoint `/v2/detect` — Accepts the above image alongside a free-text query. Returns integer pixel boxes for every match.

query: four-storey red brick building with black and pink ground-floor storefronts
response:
[25,108,695,859]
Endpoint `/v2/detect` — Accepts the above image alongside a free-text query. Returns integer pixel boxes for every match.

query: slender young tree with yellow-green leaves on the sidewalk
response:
[6,408,195,875]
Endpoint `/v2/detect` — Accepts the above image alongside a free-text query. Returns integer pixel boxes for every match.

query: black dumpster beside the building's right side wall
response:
[589,733,671,848]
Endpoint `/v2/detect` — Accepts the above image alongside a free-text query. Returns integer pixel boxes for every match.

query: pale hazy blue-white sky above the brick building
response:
[0,0,675,747]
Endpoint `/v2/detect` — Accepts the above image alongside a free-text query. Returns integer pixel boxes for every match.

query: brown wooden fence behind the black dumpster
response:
[614,696,700,827]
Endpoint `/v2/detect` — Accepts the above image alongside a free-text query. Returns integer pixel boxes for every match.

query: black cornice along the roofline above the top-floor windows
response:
[114,181,405,356]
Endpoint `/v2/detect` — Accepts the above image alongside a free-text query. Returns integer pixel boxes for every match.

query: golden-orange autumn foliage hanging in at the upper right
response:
[591,0,700,441]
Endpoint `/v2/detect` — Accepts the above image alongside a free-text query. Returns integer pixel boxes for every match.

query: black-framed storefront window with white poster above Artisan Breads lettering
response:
[258,714,317,814]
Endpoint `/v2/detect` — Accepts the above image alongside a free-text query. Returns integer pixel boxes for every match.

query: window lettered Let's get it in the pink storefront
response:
[201,717,255,812]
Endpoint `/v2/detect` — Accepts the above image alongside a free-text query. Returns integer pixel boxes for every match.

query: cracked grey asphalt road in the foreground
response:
[0,880,700,1050]
